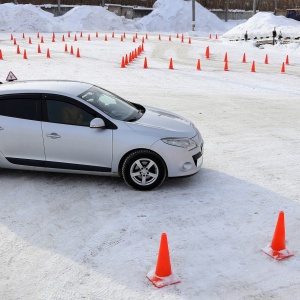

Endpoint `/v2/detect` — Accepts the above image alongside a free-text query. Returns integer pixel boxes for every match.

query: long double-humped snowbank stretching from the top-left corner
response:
[0,3,136,32]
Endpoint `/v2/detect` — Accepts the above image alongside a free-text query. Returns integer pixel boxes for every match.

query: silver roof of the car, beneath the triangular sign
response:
[0,80,93,96]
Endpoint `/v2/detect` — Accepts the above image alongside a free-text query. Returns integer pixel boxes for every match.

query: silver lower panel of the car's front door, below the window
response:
[42,122,112,172]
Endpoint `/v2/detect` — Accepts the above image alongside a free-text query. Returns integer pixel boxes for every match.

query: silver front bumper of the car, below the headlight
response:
[151,140,203,177]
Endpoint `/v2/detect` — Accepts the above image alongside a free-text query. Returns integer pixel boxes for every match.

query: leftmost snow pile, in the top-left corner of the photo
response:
[0,3,55,32]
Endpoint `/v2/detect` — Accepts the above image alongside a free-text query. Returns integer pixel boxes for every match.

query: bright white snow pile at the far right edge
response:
[222,12,300,38]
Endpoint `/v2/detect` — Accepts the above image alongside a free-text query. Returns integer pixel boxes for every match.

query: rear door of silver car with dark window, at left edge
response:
[0,94,45,167]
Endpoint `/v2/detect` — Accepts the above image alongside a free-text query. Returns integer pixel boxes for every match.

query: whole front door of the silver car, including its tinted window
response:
[42,94,112,172]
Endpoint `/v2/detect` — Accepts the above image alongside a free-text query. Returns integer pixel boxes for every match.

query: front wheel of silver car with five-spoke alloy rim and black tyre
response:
[122,150,167,191]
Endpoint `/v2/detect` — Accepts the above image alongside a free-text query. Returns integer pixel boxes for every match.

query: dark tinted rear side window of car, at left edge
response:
[0,98,39,121]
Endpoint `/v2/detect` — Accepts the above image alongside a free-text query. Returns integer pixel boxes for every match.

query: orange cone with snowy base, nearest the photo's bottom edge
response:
[146,233,180,288]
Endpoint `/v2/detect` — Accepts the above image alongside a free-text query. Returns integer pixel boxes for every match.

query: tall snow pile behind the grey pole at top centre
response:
[137,0,224,33]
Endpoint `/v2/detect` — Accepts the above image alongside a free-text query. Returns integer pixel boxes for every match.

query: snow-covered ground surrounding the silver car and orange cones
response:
[0,1,300,300]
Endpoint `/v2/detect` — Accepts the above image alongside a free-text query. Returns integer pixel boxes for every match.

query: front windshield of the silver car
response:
[78,85,144,122]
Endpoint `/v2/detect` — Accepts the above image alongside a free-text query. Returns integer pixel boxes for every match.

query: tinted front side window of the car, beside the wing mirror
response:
[46,100,95,126]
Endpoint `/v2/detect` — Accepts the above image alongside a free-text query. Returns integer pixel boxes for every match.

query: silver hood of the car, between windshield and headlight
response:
[127,106,197,138]
